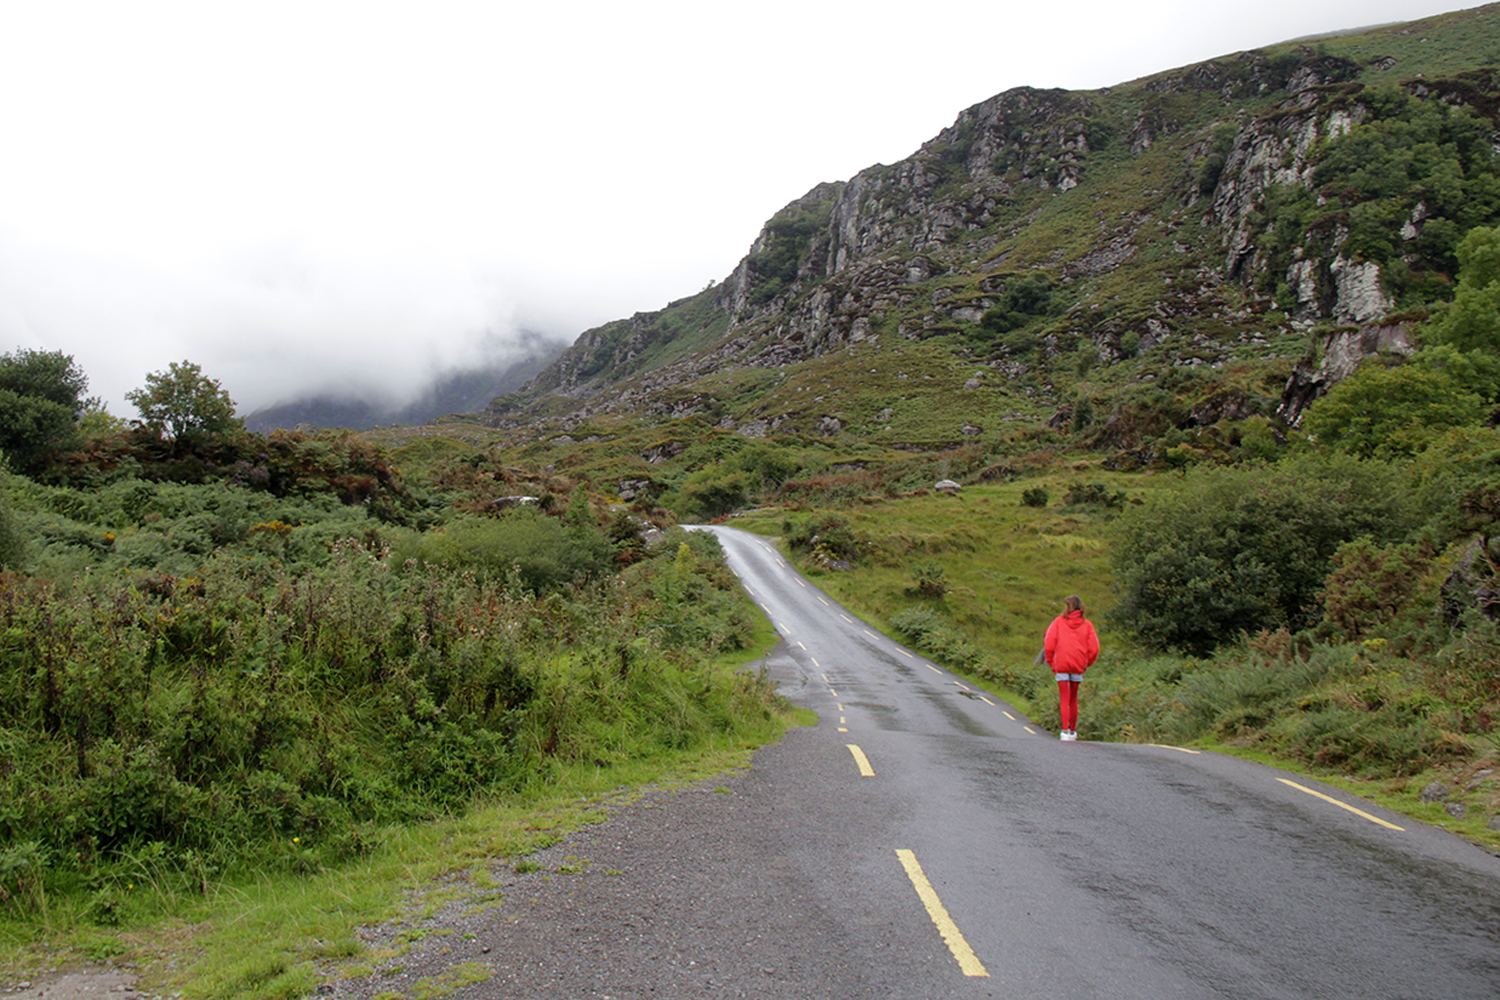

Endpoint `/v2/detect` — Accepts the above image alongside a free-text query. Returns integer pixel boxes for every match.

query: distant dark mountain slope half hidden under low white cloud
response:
[245,339,563,433]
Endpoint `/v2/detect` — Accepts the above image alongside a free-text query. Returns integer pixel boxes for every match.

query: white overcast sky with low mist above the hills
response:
[0,0,1475,417]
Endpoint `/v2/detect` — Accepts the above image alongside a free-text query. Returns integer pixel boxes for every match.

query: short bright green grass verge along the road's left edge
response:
[0,618,809,1000]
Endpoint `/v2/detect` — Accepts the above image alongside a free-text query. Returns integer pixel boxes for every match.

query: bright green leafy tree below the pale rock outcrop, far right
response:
[1302,360,1485,459]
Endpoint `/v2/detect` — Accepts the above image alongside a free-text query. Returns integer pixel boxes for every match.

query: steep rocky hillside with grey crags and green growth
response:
[483,6,1500,451]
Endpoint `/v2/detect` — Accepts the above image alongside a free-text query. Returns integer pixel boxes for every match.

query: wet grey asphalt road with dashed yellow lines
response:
[336,528,1500,1000]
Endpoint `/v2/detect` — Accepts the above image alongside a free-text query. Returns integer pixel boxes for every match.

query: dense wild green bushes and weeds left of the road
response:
[0,524,771,917]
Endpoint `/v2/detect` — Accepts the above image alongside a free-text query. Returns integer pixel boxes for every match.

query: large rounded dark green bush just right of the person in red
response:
[1110,456,1418,654]
